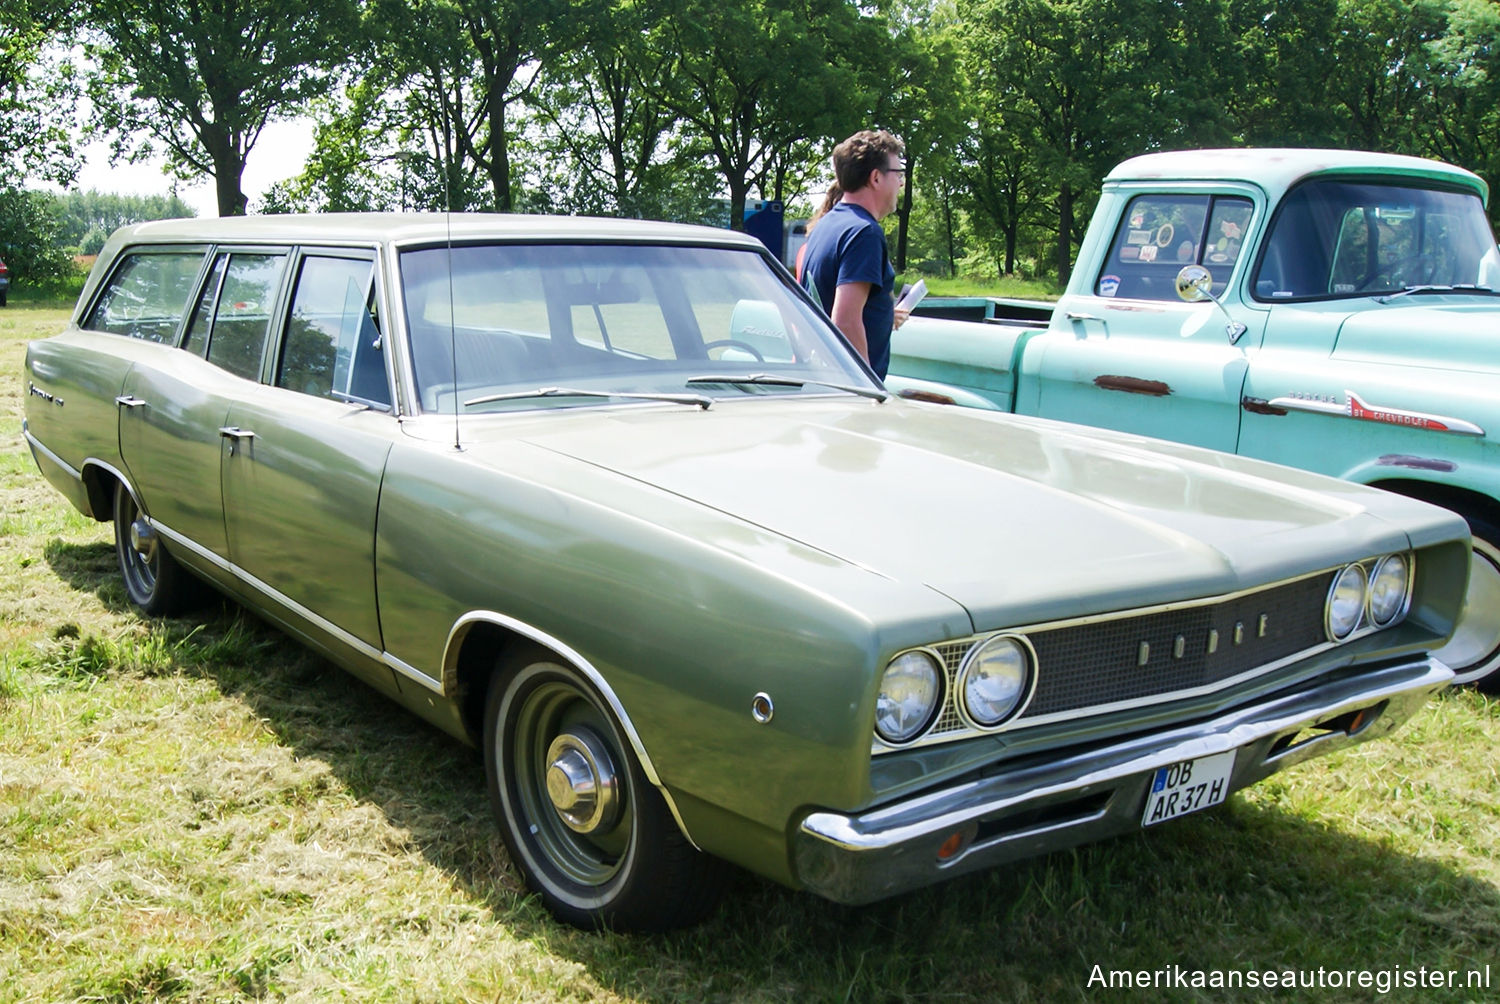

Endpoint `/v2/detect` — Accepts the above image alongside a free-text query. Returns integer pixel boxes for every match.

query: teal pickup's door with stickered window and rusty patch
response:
[1017,192,1265,452]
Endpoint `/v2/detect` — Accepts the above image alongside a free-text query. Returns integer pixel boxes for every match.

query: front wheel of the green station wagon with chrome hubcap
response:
[485,653,723,930]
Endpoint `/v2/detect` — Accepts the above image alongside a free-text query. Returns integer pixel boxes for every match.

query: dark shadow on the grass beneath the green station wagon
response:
[47,545,1500,1002]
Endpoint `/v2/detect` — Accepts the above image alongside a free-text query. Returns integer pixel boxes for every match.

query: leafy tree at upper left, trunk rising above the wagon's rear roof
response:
[89,0,357,216]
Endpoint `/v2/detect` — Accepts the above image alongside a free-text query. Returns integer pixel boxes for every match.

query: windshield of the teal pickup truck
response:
[1253,180,1500,300]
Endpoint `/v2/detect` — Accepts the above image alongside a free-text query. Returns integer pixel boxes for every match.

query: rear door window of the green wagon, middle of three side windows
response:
[183,252,287,380]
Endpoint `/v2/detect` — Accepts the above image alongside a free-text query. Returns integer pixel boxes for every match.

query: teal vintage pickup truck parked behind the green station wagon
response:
[887,150,1500,690]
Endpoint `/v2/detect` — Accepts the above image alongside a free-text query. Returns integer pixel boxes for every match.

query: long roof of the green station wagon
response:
[114,213,762,248]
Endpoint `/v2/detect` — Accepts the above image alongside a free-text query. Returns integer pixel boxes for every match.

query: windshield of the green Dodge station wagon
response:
[401,243,879,413]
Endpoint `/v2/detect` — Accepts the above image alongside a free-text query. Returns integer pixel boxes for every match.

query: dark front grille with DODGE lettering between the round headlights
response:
[926,573,1334,741]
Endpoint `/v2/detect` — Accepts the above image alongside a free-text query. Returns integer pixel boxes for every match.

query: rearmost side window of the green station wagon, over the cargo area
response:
[84,251,203,344]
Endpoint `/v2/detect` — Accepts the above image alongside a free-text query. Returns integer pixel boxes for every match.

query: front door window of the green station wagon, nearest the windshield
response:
[276,255,390,407]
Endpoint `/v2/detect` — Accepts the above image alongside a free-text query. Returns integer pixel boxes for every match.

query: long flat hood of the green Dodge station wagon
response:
[444,399,1409,630]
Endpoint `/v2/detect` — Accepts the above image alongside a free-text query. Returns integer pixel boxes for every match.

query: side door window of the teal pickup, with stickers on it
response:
[1094,194,1253,300]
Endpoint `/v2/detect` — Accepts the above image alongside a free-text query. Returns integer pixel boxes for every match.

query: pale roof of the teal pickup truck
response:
[1104,147,1490,201]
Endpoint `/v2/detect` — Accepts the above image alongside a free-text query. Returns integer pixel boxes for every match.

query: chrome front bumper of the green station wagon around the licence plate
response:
[792,659,1454,903]
